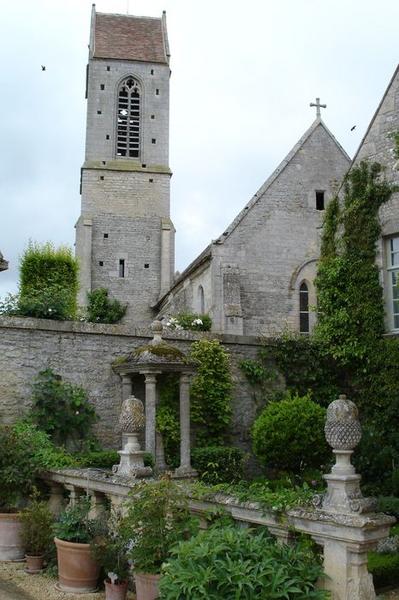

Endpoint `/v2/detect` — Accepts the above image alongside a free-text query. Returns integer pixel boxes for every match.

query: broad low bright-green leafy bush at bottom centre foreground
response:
[160,527,327,600]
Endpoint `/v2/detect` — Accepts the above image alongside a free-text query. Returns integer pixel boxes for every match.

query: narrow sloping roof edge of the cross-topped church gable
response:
[155,118,351,306]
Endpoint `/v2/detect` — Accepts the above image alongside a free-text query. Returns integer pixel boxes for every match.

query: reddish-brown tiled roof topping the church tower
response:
[91,11,169,64]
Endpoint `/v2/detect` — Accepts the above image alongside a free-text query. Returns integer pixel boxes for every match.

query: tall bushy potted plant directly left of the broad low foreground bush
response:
[126,477,198,600]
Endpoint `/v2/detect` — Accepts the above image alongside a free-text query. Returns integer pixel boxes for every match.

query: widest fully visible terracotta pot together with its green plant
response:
[54,496,103,594]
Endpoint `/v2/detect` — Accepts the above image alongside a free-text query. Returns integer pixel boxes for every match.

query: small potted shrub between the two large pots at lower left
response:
[21,490,53,573]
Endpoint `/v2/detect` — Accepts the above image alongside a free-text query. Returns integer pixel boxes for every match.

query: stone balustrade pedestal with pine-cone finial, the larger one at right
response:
[288,395,395,600]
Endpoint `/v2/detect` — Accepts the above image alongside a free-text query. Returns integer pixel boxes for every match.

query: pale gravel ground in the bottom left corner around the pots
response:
[0,562,135,600]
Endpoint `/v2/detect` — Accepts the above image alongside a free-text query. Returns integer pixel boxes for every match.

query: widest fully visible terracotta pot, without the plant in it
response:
[54,538,100,594]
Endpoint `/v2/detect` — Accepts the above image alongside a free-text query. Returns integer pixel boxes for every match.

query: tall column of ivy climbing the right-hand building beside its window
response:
[316,162,393,364]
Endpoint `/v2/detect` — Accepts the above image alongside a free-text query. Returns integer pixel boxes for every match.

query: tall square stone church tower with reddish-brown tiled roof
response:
[76,5,175,324]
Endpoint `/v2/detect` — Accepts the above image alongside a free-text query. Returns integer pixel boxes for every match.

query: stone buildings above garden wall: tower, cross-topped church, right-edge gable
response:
[76,6,399,335]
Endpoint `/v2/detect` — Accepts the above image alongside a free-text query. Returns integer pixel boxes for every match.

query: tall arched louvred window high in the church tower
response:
[116,77,141,158]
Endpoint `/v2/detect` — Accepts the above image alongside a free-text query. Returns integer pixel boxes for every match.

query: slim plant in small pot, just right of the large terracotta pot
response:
[91,509,130,600]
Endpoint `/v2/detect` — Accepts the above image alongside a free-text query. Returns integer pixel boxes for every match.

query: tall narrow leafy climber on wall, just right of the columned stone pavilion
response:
[190,339,233,446]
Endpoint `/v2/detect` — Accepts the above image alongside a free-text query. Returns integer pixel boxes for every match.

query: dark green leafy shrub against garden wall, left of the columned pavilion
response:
[32,369,97,444]
